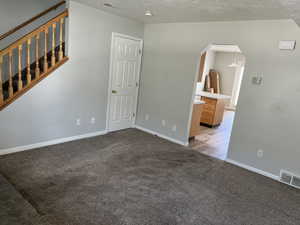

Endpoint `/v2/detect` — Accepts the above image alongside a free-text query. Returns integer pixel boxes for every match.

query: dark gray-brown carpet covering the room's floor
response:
[0,129,300,225]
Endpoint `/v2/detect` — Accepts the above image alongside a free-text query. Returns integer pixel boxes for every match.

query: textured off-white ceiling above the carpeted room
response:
[73,0,300,24]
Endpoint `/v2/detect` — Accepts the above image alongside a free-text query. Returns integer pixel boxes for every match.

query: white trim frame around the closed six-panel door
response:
[106,32,144,132]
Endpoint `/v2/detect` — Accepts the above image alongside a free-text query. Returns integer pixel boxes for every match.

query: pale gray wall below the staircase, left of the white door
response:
[0,2,144,153]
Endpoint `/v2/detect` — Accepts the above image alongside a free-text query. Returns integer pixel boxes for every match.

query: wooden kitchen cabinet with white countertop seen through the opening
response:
[200,97,227,127]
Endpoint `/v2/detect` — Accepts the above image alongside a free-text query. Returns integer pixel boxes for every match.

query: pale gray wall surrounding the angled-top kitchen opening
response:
[137,20,300,175]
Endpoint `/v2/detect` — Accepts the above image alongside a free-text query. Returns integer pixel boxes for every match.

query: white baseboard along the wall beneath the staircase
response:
[0,131,107,155]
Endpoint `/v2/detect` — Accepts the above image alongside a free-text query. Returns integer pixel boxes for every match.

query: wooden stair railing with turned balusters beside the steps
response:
[0,10,68,110]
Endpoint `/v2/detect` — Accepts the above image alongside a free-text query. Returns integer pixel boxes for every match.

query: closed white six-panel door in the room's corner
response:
[107,33,142,131]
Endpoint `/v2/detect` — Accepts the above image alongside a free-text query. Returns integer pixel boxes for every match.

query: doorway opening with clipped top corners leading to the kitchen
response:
[189,44,246,160]
